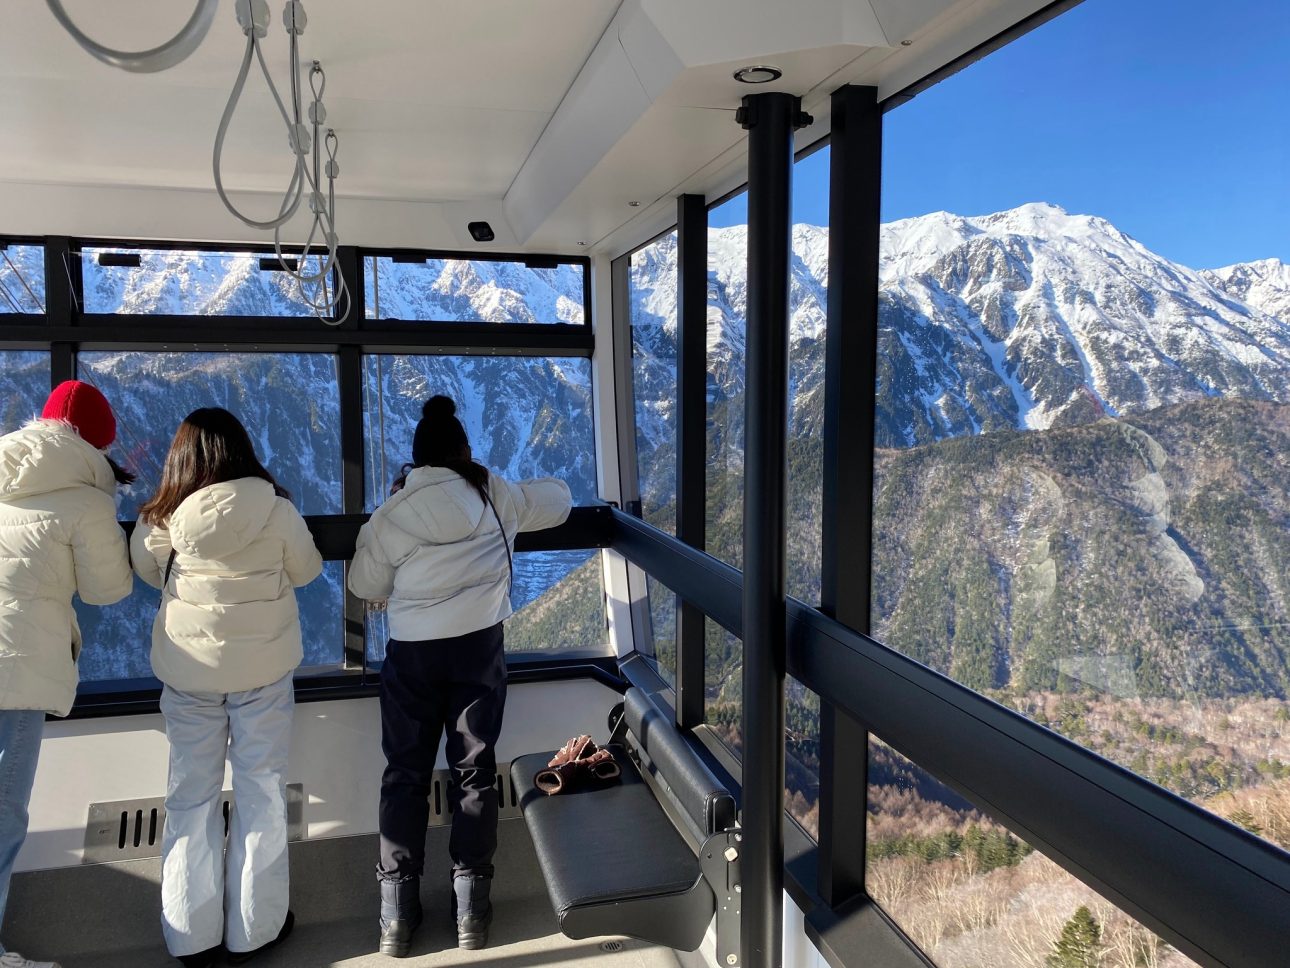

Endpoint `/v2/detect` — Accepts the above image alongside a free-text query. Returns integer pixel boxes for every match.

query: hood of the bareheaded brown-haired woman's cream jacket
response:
[170,478,277,559]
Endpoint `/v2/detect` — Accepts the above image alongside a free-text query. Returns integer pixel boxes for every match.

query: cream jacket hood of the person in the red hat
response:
[0,419,116,501]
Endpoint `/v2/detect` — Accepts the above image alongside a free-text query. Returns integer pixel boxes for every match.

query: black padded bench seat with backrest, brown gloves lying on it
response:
[511,688,740,964]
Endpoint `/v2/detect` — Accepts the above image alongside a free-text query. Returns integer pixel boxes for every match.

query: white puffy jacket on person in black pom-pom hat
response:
[350,467,573,641]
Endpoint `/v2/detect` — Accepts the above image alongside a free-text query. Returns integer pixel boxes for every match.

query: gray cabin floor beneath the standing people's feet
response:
[4,821,677,968]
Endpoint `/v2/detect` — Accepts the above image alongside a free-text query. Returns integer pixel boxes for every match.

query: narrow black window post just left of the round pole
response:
[676,195,708,729]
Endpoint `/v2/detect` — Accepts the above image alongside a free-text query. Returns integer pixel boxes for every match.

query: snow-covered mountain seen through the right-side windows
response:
[632,204,1290,462]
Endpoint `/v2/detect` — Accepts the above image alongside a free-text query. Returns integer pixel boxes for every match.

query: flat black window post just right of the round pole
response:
[818,85,882,909]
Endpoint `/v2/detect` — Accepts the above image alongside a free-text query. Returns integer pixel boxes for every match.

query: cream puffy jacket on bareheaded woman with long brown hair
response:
[130,478,323,693]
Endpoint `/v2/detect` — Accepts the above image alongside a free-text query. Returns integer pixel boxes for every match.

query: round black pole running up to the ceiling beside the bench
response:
[737,93,804,968]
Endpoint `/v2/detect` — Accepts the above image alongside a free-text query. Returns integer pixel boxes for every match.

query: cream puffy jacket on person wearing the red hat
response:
[0,421,134,716]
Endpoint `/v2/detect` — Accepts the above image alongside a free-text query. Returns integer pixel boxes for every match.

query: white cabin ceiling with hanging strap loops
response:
[0,0,1062,252]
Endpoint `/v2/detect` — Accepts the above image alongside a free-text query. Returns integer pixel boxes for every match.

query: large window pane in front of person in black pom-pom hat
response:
[362,356,597,511]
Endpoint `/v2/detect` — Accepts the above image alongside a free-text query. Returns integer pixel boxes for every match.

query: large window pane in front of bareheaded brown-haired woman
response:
[76,352,342,520]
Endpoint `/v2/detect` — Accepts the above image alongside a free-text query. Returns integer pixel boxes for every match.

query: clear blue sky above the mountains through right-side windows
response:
[712,0,1290,268]
